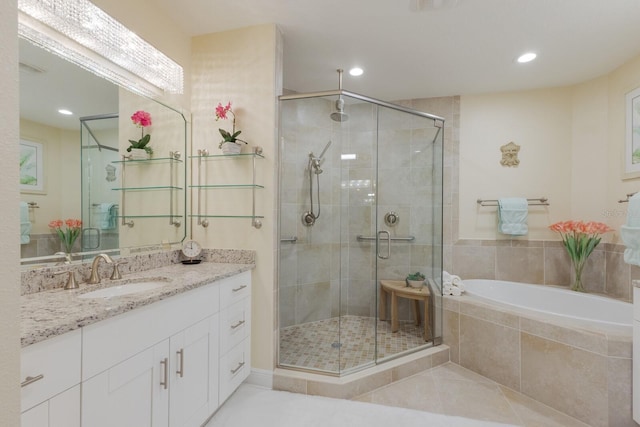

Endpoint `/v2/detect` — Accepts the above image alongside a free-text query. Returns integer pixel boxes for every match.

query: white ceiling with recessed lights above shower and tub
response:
[149,0,640,101]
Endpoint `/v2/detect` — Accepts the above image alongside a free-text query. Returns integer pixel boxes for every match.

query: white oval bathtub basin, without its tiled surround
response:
[464,279,633,330]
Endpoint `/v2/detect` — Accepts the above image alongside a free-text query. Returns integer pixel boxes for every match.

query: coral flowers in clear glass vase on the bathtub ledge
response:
[549,221,613,292]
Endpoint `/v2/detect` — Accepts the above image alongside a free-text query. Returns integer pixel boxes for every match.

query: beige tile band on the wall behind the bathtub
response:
[445,239,640,302]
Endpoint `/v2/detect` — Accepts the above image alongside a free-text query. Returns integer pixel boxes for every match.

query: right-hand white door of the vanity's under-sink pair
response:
[169,314,219,427]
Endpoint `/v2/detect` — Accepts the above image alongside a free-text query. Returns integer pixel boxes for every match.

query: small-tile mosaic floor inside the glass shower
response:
[279,316,427,372]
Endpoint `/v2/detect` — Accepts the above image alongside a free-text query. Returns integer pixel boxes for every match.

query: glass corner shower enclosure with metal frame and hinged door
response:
[277,90,444,375]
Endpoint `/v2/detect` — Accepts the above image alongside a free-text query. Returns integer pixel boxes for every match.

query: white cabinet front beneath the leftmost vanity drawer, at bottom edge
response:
[20,385,80,427]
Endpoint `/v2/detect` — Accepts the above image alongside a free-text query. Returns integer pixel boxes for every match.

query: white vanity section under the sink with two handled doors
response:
[82,272,251,427]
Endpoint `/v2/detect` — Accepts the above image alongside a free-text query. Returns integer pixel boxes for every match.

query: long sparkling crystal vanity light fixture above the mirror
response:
[18,0,184,98]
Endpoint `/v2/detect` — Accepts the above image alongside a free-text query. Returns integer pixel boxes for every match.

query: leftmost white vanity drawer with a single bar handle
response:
[20,329,81,411]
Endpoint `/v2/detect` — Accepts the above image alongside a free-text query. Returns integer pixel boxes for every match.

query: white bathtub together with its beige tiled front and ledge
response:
[443,279,635,427]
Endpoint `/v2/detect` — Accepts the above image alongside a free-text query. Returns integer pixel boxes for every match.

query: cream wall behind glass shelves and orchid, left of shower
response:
[191,25,281,370]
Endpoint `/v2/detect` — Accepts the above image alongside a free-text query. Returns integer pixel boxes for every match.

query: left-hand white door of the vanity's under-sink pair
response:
[82,340,170,427]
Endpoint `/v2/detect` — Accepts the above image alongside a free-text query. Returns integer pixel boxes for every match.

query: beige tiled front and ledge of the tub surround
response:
[444,295,637,427]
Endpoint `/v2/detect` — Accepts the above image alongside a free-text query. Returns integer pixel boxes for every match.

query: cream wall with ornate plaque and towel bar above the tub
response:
[459,89,572,240]
